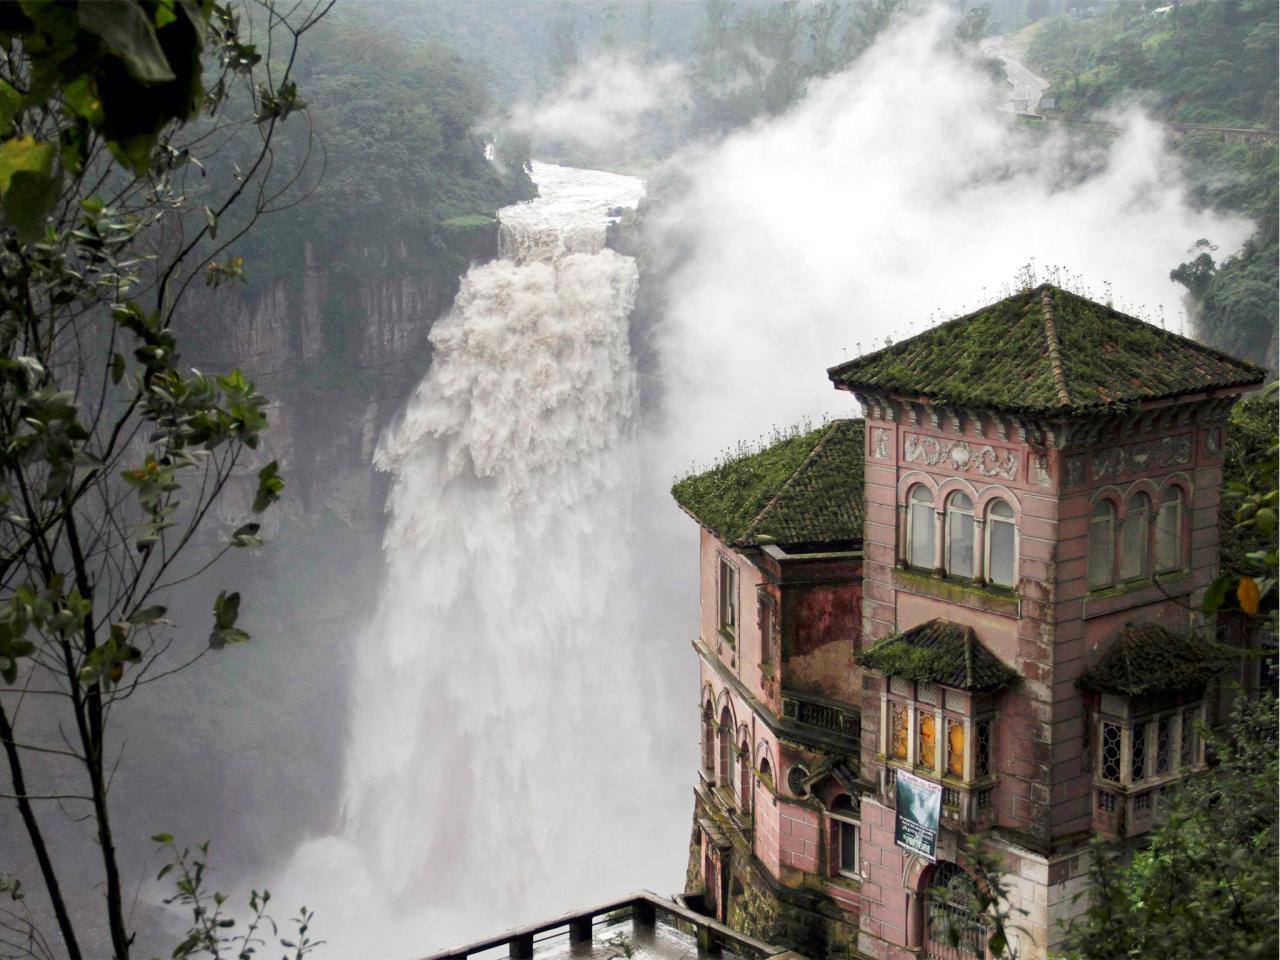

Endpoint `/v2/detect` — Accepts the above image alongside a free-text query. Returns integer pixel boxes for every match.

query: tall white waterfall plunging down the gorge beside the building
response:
[281,164,684,954]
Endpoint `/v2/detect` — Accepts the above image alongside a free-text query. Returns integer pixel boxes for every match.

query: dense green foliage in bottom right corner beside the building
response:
[1070,692,1280,960]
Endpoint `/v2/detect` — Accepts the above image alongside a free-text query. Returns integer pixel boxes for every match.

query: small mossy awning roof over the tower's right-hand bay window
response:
[1080,623,1229,696]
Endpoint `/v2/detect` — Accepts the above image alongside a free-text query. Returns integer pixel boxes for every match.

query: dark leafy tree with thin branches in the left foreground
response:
[0,0,324,957]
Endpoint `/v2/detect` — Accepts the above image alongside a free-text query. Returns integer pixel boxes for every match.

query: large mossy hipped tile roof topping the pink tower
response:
[827,284,1266,415]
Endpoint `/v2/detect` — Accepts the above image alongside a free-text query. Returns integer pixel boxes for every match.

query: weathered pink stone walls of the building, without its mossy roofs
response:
[691,390,1238,960]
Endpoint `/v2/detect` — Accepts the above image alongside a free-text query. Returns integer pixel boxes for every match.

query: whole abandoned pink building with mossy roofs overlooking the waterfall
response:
[673,285,1265,960]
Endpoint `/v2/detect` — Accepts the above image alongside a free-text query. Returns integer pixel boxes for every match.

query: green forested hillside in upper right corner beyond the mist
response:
[1028,0,1280,370]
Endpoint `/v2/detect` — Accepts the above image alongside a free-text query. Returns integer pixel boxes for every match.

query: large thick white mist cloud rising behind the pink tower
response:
[650,9,1249,471]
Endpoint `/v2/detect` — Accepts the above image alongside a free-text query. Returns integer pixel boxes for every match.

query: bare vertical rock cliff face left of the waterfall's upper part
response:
[179,224,497,534]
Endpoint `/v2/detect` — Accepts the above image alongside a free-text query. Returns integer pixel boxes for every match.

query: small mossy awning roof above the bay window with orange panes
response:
[858,620,1018,692]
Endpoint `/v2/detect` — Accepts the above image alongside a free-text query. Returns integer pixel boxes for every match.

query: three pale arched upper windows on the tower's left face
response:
[906,485,1018,586]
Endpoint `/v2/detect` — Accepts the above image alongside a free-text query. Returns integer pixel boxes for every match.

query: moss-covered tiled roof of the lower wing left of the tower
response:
[671,420,864,547]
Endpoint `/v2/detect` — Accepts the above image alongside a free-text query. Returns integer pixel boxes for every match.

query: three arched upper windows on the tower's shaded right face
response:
[1088,486,1184,590]
